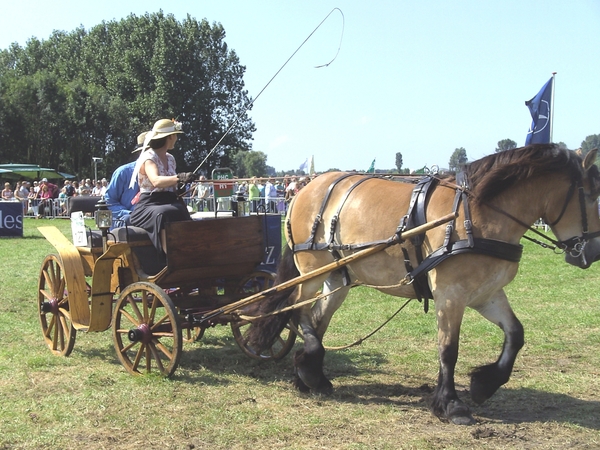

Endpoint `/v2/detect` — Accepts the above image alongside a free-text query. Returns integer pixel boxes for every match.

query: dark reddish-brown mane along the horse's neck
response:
[465,144,583,202]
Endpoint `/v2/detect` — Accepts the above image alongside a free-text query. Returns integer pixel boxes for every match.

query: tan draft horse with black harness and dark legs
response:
[249,144,600,424]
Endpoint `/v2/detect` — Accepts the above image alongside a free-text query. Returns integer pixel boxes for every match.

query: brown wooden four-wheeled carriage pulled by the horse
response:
[37,215,296,376]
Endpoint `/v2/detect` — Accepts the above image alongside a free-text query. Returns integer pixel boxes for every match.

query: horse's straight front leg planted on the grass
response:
[431,298,475,425]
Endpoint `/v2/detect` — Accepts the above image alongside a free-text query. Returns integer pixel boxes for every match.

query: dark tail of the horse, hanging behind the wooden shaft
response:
[246,246,300,351]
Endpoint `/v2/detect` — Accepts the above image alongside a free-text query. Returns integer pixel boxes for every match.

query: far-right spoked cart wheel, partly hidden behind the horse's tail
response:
[231,272,296,360]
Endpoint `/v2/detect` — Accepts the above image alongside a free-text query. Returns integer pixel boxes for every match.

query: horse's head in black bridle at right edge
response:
[552,149,600,269]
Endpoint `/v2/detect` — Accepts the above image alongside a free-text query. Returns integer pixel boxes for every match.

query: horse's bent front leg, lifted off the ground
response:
[471,290,524,404]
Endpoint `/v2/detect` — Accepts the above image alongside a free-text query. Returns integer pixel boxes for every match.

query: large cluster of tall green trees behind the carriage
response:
[0,11,255,178]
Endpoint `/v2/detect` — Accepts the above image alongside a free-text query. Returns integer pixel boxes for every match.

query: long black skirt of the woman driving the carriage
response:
[130,192,192,255]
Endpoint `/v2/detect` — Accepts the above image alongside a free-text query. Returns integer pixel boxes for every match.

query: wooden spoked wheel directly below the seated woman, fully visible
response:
[112,281,183,377]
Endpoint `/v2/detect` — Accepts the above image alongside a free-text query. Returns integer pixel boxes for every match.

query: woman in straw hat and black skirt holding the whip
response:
[130,119,198,256]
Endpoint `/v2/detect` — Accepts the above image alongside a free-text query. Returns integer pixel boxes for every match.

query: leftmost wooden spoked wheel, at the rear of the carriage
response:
[37,255,77,356]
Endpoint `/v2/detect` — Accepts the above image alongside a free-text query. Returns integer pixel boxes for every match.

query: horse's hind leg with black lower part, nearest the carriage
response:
[294,273,350,395]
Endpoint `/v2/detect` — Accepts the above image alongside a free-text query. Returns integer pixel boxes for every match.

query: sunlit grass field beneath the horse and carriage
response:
[0,219,600,449]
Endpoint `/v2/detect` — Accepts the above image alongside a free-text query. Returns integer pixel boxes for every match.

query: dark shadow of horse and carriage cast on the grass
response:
[76,336,600,430]
